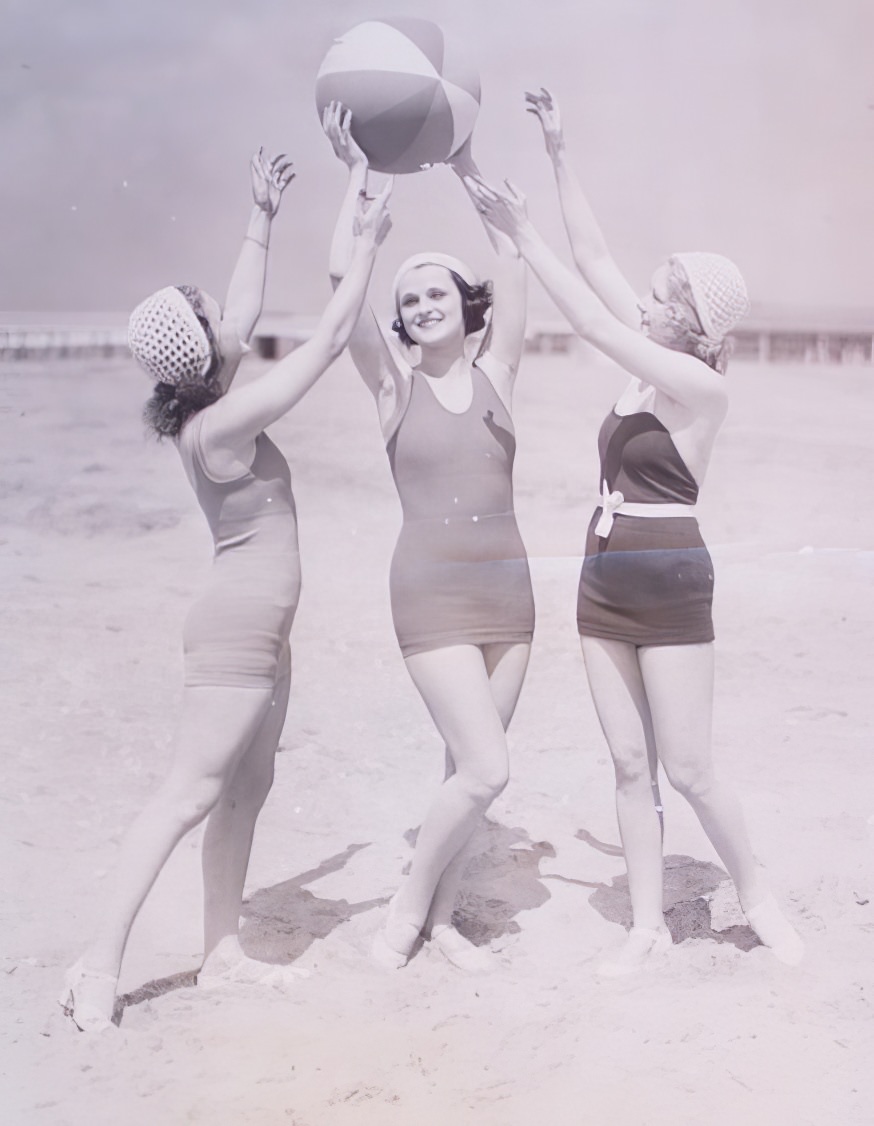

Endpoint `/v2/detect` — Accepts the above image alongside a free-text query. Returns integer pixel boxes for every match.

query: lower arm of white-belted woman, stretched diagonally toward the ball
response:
[469,180,725,417]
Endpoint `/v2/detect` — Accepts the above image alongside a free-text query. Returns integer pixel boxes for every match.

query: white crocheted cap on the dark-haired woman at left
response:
[127,286,213,386]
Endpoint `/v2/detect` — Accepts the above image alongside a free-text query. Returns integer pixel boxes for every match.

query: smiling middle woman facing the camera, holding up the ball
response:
[323,104,534,972]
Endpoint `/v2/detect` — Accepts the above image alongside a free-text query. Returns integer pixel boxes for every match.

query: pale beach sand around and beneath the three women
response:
[0,349,874,1126]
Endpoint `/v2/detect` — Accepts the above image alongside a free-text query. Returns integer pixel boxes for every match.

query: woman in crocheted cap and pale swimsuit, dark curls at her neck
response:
[61,153,390,1031]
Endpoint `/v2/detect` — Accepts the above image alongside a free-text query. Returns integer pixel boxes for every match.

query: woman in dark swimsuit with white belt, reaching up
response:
[470,90,802,975]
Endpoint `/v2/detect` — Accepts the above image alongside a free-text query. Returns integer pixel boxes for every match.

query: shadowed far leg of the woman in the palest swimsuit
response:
[203,646,291,959]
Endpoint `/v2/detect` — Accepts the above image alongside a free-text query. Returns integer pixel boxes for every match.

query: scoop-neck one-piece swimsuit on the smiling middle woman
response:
[386,352,534,656]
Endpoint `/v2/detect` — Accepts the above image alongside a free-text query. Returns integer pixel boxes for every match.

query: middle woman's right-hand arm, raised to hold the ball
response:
[447,138,528,376]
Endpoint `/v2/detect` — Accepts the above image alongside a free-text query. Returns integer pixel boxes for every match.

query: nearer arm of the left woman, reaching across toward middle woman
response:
[204,185,391,465]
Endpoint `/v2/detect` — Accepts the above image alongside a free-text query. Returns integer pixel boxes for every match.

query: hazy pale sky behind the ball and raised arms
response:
[0,0,874,314]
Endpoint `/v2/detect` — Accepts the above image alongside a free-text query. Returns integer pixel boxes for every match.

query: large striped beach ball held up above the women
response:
[315,16,480,172]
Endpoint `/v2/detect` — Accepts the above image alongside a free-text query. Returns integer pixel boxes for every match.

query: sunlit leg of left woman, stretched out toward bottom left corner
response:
[70,688,273,1019]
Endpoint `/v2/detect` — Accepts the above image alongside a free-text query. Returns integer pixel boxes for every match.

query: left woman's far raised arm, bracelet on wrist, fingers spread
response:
[222,149,294,343]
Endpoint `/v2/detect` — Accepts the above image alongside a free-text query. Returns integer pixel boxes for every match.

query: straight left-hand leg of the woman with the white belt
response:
[581,637,665,930]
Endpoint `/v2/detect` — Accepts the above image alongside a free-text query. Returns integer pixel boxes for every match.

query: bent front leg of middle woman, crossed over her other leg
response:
[376,645,524,955]
